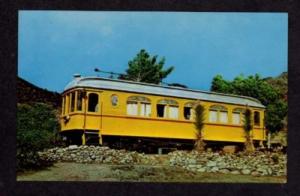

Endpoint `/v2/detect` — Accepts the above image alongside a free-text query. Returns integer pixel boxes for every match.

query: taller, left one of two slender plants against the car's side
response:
[194,103,206,152]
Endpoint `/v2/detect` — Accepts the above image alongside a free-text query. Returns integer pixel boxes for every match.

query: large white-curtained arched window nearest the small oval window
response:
[127,96,151,117]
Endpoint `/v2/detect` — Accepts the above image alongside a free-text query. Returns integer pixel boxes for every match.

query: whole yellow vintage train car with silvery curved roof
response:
[61,75,266,150]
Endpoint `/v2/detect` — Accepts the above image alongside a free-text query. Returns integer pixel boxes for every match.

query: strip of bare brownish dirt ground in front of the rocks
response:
[17,162,286,183]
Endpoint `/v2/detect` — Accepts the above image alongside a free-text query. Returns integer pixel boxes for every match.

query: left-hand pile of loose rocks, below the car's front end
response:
[39,145,163,165]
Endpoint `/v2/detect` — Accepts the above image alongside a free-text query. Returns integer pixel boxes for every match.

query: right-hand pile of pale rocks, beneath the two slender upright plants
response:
[169,151,286,176]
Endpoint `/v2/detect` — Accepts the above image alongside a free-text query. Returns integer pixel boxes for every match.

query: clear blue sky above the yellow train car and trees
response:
[18,11,288,92]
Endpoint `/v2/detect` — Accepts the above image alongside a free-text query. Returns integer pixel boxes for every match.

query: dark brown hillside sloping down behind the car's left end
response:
[17,77,61,108]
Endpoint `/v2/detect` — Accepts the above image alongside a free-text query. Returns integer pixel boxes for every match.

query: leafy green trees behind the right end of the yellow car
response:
[211,74,287,132]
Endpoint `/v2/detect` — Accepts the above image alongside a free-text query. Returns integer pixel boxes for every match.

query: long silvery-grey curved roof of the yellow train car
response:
[64,77,265,108]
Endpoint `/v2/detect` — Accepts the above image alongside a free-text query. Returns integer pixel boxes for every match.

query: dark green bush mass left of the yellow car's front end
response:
[17,103,59,171]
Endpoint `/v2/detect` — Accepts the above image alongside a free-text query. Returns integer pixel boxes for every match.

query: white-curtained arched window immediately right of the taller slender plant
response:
[209,105,228,123]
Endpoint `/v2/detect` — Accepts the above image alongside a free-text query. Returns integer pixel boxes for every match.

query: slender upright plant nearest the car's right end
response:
[243,109,255,152]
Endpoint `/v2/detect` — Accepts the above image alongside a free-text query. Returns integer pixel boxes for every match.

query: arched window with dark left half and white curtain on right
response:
[156,99,179,119]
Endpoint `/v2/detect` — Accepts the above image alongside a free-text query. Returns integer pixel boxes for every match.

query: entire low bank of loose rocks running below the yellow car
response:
[39,145,287,176]
